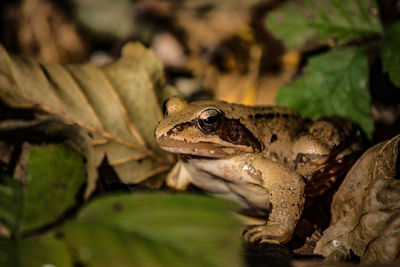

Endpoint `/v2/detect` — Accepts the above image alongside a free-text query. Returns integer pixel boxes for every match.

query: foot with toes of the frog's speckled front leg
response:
[243,224,293,244]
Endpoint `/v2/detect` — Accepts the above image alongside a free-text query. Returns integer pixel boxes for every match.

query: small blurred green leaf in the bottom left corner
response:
[0,236,73,267]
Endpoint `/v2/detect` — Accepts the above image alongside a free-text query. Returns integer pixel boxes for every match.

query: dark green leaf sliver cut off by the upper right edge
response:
[381,22,400,87]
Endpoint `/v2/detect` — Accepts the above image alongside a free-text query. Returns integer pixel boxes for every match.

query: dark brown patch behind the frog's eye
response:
[215,118,264,151]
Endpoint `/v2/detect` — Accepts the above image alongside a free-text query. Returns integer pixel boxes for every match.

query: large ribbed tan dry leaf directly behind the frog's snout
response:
[0,43,174,188]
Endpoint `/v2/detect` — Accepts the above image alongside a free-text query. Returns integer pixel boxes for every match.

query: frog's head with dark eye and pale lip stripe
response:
[155,96,262,158]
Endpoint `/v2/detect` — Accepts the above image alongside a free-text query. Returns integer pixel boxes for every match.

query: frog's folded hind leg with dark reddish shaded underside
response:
[304,116,365,197]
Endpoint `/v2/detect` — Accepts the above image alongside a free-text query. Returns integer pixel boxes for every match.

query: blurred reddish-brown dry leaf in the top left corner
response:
[0,0,88,63]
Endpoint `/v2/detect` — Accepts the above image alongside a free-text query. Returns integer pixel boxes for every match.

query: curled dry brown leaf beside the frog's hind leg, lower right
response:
[314,135,400,263]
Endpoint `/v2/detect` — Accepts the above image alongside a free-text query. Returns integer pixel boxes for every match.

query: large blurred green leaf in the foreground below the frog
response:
[61,193,242,266]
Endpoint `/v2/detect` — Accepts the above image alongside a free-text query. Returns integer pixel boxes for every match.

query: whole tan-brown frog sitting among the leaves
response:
[155,96,362,243]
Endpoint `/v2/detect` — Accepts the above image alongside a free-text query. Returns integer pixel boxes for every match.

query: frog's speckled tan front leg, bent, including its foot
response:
[244,158,305,244]
